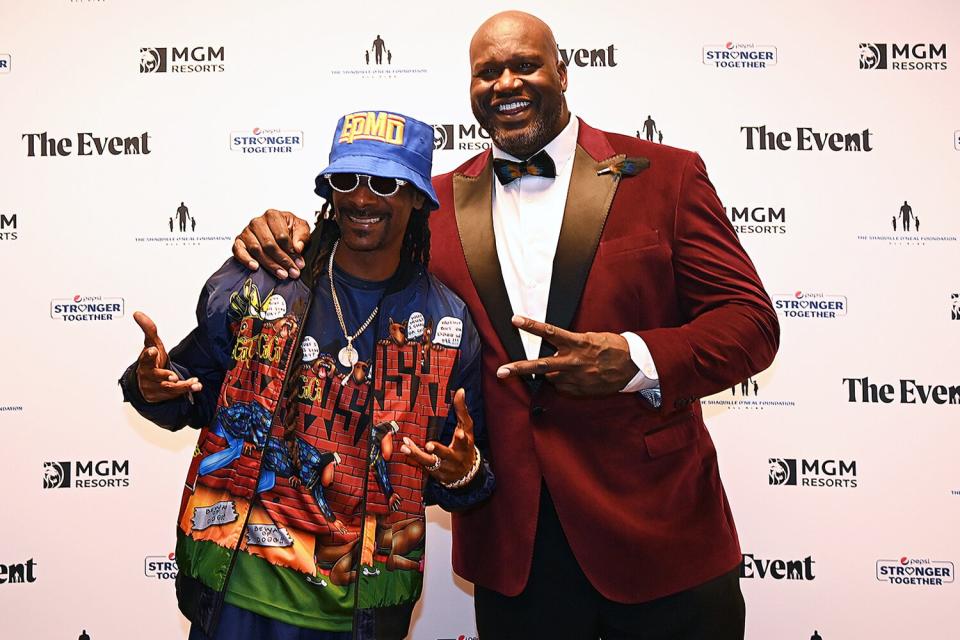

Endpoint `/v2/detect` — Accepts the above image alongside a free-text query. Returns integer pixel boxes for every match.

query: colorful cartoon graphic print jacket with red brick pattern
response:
[120,260,494,638]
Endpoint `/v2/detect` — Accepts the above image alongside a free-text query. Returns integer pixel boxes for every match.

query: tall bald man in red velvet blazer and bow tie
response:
[235,12,779,640]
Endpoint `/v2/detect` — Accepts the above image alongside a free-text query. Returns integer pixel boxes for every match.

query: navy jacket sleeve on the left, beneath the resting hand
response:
[119,259,247,431]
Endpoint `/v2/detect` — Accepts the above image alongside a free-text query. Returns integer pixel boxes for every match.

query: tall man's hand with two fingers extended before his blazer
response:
[497,316,639,396]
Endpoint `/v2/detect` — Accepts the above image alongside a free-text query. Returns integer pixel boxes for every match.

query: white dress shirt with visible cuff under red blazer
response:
[493,115,660,392]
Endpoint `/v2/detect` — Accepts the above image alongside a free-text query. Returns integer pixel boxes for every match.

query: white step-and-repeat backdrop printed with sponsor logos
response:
[0,0,960,640]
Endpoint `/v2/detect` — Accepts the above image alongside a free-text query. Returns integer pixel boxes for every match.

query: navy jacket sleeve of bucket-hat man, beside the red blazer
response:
[424,307,496,511]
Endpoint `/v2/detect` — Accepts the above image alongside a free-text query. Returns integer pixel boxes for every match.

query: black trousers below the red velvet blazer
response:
[474,485,745,640]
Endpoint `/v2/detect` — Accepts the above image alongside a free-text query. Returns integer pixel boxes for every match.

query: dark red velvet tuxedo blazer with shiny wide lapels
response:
[430,117,779,603]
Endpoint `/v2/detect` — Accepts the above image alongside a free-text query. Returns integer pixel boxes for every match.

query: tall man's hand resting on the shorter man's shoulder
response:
[233,209,310,280]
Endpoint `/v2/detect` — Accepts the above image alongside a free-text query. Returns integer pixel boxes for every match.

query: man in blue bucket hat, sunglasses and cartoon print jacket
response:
[120,111,494,640]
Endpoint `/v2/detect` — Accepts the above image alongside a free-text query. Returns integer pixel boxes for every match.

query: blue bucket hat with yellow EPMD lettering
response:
[314,111,440,211]
